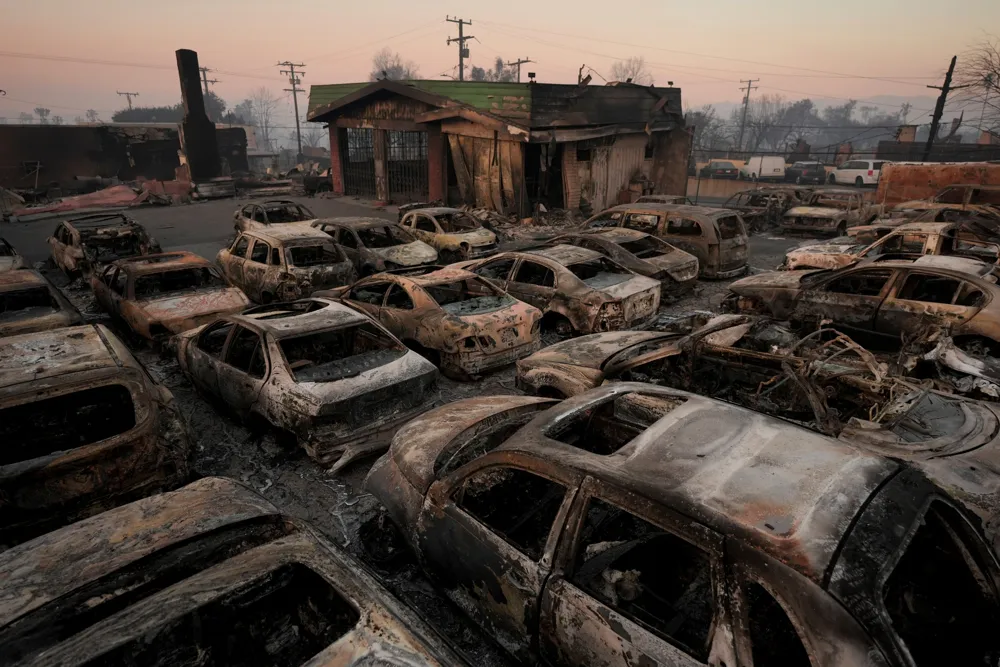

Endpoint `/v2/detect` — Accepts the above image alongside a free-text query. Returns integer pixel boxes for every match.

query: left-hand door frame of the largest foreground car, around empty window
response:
[416,452,584,658]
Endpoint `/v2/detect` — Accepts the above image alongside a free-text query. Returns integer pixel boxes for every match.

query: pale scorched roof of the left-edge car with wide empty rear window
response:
[0,325,122,389]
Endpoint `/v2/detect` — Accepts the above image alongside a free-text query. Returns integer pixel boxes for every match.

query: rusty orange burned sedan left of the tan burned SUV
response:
[90,251,250,342]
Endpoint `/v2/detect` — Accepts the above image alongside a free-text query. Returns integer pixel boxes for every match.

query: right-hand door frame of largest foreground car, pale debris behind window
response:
[538,476,738,667]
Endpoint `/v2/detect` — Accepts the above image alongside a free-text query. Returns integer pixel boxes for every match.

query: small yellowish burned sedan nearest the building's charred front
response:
[399,206,497,264]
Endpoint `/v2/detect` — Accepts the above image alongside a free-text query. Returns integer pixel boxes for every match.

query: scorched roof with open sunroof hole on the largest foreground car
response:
[494,382,899,583]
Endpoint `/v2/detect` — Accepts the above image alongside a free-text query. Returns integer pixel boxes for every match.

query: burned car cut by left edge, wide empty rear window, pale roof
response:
[0,325,191,548]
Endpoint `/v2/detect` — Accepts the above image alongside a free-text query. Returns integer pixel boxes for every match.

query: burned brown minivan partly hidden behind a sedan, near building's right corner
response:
[579,204,749,278]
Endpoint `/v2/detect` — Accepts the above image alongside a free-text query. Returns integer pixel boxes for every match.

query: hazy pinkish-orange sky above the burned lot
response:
[0,0,1000,134]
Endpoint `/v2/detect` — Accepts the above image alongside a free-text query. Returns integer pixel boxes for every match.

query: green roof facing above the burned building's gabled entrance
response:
[307,79,531,119]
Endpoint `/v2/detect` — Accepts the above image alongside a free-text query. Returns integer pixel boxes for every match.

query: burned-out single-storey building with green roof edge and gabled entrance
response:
[308,80,690,217]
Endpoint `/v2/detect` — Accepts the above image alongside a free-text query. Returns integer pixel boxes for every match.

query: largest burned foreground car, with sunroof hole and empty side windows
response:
[365,383,1000,667]
